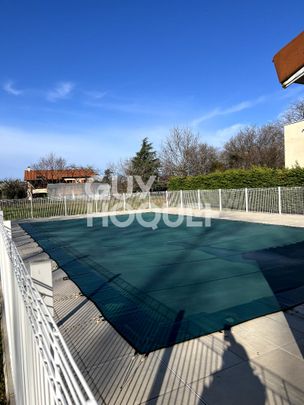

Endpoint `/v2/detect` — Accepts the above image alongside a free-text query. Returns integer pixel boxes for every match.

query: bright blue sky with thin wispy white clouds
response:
[0,0,304,178]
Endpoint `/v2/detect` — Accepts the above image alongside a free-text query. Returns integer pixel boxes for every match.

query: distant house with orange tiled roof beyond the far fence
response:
[24,167,96,198]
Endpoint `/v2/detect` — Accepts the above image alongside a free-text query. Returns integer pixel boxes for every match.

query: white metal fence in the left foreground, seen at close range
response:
[0,212,96,405]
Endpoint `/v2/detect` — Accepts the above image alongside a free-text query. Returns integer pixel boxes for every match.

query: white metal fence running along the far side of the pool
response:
[0,187,304,219]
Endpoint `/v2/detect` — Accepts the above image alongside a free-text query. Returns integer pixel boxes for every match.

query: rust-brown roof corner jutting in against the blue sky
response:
[273,31,304,87]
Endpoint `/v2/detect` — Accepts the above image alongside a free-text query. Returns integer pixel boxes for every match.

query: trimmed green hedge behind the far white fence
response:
[168,167,304,190]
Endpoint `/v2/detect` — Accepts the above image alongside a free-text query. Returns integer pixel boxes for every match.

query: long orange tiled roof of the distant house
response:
[24,169,96,181]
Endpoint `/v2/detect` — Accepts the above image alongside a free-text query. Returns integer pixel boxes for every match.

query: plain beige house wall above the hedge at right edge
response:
[284,121,304,168]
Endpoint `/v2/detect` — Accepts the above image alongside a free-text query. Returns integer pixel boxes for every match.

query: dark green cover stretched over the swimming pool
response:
[22,213,304,353]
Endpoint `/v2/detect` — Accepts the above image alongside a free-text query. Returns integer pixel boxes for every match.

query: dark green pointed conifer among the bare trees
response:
[126,138,160,191]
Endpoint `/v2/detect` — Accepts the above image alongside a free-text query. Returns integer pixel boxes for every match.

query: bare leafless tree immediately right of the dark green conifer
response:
[160,127,218,177]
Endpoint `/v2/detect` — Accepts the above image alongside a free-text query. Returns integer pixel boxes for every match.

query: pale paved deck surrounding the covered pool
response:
[12,208,304,405]
